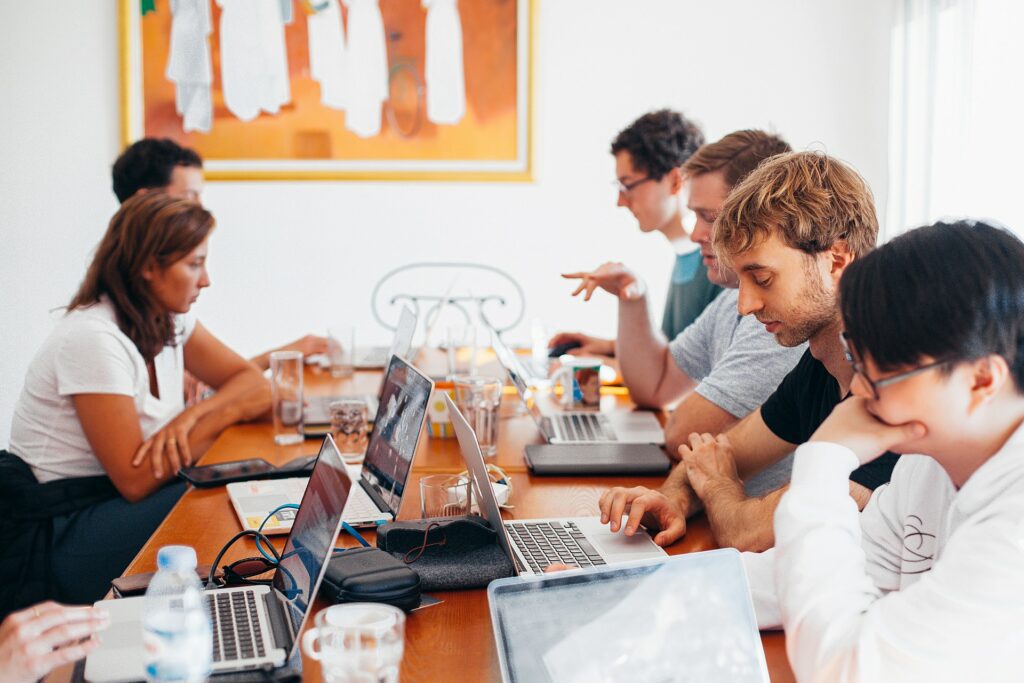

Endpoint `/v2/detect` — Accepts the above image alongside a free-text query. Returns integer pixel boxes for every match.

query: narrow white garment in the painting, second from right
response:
[344,0,388,137]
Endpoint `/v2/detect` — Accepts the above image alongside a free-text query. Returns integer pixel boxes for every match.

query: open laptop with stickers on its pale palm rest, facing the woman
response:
[227,355,434,533]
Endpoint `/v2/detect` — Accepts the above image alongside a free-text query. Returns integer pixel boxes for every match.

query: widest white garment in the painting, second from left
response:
[217,0,292,121]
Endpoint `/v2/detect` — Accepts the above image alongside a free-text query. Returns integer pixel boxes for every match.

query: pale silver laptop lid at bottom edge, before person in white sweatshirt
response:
[487,548,769,683]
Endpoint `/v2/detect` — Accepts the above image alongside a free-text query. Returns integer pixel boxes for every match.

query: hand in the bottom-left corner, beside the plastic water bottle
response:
[0,602,109,683]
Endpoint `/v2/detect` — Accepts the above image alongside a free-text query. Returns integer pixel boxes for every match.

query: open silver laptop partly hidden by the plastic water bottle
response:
[85,436,352,682]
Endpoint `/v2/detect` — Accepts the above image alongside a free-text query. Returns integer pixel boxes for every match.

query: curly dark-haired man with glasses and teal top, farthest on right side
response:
[549,110,722,356]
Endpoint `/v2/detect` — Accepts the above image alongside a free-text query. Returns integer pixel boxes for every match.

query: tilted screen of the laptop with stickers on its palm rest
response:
[360,355,434,517]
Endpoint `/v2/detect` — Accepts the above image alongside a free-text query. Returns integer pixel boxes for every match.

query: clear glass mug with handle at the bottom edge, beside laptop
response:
[302,602,406,683]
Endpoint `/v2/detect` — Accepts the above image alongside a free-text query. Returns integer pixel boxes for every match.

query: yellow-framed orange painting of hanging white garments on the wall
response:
[119,0,537,181]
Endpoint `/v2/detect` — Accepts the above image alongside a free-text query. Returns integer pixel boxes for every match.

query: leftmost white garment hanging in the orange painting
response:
[166,0,213,133]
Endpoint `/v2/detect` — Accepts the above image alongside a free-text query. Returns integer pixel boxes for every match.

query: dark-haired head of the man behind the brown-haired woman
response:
[112,137,203,203]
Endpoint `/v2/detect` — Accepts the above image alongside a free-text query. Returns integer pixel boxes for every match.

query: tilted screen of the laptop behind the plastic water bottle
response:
[273,435,352,658]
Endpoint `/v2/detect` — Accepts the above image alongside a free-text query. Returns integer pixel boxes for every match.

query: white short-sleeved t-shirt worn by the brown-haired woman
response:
[10,297,196,482]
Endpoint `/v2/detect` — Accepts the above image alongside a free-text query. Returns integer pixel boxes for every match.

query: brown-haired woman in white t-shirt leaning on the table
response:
[3,193,269,602]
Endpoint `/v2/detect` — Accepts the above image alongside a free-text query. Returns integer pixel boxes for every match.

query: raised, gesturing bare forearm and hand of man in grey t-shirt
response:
[562,263,696,408]
